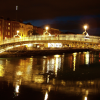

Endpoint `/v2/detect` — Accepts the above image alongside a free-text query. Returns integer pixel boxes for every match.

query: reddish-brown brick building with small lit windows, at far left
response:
[0,18,20,41]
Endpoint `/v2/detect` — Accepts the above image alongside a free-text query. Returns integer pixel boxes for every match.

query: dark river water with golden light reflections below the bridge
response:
[0,52,100,100]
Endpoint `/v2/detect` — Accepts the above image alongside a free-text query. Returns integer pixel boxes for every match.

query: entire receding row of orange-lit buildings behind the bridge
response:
[0,17,61,41]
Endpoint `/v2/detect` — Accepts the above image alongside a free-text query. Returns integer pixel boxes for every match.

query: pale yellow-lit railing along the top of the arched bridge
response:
[0,34,100,45]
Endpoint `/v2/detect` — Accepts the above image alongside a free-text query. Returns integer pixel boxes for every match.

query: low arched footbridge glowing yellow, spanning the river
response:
[0,34,100,52]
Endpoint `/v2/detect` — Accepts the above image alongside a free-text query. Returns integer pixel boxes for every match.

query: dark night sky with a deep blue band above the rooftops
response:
[0,0,100,35]
